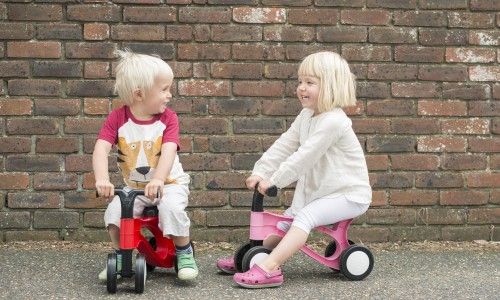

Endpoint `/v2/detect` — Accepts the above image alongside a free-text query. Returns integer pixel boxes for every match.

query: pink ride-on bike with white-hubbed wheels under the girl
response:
[234,186,374,280]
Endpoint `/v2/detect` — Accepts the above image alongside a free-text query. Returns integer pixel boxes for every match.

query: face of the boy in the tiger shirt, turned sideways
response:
[143,75,172,115]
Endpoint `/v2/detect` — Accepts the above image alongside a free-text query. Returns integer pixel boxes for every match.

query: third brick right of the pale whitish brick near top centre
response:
[394,11,446,27]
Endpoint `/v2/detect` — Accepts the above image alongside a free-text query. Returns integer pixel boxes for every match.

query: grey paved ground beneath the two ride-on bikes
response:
[0,241,500,300]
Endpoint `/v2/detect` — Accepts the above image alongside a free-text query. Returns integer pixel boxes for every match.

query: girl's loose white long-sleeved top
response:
[252,108,372,215]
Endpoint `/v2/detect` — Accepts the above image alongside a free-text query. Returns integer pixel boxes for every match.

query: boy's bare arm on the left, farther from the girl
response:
[92,139,115,198]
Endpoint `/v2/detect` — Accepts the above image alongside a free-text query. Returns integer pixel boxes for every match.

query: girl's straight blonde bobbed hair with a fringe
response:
[298,51,356,113]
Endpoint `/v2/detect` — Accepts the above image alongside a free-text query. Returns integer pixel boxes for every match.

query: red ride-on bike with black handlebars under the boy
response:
[96,189,194,293]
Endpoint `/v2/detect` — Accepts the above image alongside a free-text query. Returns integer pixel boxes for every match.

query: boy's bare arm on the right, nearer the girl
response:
[144,142,177,201]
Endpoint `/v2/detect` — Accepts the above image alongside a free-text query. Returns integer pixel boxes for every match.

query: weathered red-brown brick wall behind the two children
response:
[0,0,500,242]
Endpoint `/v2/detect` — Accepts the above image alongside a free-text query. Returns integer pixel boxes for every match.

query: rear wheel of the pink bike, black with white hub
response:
[340,245,374,280]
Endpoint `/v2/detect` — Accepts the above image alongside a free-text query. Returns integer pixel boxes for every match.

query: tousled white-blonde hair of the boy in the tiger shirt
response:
[115,49,174,105]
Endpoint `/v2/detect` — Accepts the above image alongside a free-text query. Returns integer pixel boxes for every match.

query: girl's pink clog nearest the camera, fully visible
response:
[233,264,283,289]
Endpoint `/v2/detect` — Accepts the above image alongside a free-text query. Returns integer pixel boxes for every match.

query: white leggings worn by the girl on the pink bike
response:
[278,195,370,234]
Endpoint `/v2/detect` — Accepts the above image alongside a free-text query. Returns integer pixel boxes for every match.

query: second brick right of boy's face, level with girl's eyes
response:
[233,81,283,97]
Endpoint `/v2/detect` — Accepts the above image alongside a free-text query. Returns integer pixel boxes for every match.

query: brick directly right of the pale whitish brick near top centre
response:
[288,8,338,25]
